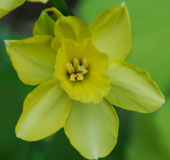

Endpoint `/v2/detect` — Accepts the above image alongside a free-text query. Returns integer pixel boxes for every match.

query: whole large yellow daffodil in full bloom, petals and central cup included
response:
[6,4,165,159]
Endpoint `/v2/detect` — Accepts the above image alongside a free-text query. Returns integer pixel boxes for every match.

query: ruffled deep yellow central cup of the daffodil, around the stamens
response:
[55,40,110,103]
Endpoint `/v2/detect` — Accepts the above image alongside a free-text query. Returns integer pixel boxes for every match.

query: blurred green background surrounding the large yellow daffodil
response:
[0,0,170,160]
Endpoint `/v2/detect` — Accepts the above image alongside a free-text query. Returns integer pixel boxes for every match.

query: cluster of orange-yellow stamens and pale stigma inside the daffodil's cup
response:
[66,58,88,81]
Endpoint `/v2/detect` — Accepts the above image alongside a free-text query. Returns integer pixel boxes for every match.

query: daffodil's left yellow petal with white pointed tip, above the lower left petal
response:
[5,36,56,85]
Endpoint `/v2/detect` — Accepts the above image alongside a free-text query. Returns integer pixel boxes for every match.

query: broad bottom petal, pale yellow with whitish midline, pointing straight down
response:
[64,100,119,159]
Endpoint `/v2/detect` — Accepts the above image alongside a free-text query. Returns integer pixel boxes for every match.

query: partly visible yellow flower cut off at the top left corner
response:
[0,0,48,18]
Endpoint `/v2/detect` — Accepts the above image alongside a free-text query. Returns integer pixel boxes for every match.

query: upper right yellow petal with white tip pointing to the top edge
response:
[90,5,132,60]
